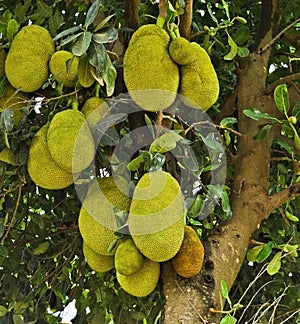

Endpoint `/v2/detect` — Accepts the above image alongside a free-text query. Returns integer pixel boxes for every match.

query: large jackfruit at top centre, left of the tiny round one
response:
[123,24,179,111]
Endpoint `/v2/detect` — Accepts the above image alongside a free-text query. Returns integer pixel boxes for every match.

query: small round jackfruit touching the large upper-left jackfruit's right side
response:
[49,50,79,87]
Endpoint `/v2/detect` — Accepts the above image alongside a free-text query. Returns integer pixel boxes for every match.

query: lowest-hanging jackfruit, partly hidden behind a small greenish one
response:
[117,259,160,297]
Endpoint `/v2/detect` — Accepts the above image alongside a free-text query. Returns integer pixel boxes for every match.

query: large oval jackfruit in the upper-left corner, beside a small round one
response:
[5,25,54,92]
